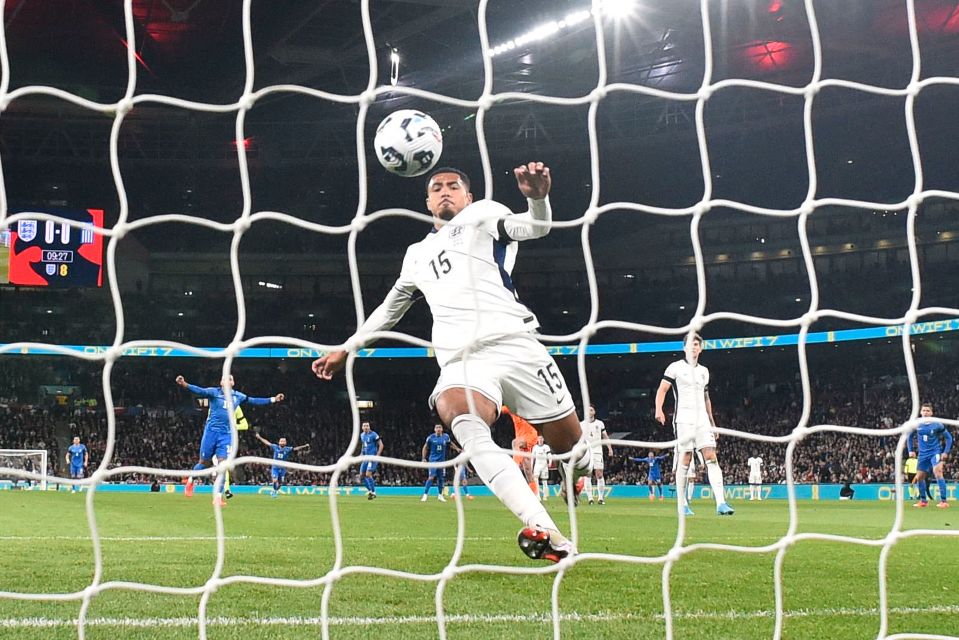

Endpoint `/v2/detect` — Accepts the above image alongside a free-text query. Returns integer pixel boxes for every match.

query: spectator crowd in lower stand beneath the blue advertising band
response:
[0,356,959,485]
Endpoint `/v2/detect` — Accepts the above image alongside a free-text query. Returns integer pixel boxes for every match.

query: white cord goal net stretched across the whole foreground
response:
[0,0,959,639]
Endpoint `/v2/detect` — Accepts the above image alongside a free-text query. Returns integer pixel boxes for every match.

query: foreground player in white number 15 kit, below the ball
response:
[313,162,589,562]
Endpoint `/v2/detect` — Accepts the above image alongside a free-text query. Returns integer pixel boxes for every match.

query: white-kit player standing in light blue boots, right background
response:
[656,334,735,516]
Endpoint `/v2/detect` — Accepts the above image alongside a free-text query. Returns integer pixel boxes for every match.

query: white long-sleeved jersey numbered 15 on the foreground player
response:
[363,200,549,366]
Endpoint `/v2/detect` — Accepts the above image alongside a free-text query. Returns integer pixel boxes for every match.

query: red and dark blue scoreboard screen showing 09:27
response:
[0,209,103,287]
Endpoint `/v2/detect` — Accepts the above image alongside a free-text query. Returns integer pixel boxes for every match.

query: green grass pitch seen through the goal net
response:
[0,492,959,640]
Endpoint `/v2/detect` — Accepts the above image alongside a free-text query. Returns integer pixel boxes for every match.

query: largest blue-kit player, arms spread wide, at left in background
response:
[176,375,285,506]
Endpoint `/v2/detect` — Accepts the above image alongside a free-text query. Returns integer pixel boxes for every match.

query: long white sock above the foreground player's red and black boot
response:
[451,413,557,530]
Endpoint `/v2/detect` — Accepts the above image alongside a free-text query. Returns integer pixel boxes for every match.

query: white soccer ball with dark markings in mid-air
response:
[373,109,443,178]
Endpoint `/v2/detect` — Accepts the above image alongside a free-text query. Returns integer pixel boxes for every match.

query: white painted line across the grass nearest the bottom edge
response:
[0,605,959,629]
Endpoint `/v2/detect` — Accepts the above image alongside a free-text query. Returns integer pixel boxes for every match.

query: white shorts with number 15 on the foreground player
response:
[430,333,576,424]
